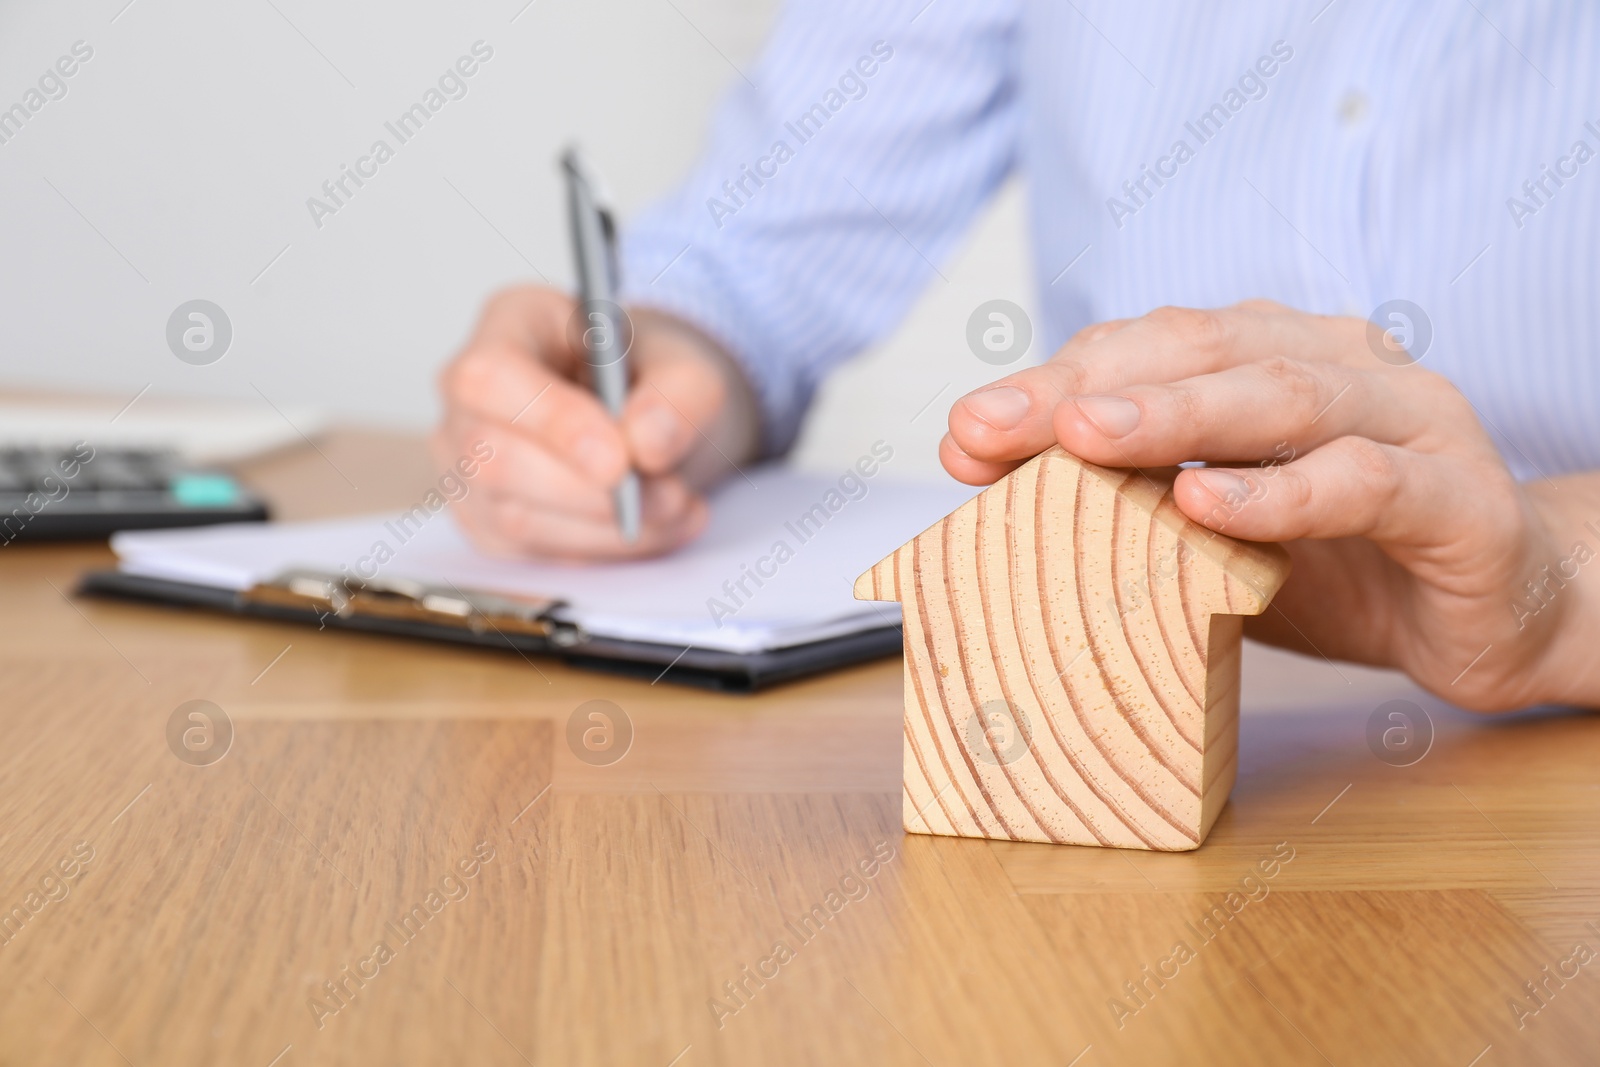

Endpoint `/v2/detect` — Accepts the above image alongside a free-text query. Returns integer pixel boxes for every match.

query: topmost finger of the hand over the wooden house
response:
[950,302,1365,462]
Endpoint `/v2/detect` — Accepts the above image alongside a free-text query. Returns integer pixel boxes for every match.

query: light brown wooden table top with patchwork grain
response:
[0,432,1600,1067]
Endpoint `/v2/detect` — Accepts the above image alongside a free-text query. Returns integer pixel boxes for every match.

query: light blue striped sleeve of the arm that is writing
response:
[622,0,1019,454]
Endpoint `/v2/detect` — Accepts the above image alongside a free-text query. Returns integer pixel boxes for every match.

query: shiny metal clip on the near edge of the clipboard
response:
[240,568,587,648]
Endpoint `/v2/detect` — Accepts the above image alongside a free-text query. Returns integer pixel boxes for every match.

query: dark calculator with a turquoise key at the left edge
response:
[0,442,267,545]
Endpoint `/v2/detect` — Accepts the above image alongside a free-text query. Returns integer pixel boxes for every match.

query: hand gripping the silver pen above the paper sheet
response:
[434,155,757,560]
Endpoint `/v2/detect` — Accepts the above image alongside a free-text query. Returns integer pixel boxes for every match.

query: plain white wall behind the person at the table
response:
[0,0,1038,477]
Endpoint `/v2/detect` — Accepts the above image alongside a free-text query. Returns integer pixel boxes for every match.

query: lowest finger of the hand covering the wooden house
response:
[1173,437,1478,547]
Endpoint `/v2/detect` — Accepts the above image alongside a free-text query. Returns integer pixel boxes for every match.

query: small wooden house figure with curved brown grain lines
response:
[854,448,1290,851]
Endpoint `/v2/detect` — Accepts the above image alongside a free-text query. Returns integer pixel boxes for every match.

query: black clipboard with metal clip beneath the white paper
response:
[77,568,902,693]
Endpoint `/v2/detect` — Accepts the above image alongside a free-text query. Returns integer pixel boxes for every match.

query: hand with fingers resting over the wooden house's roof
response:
[939,301,1600,710]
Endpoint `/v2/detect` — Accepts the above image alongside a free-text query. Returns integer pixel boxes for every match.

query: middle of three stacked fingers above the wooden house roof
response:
[1053,357,1429,467]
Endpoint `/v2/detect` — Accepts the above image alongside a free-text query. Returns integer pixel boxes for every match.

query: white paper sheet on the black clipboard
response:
[112,466,976,653]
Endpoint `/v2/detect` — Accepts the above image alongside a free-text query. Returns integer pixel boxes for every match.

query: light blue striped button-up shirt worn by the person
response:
[624,0,1600,478]
